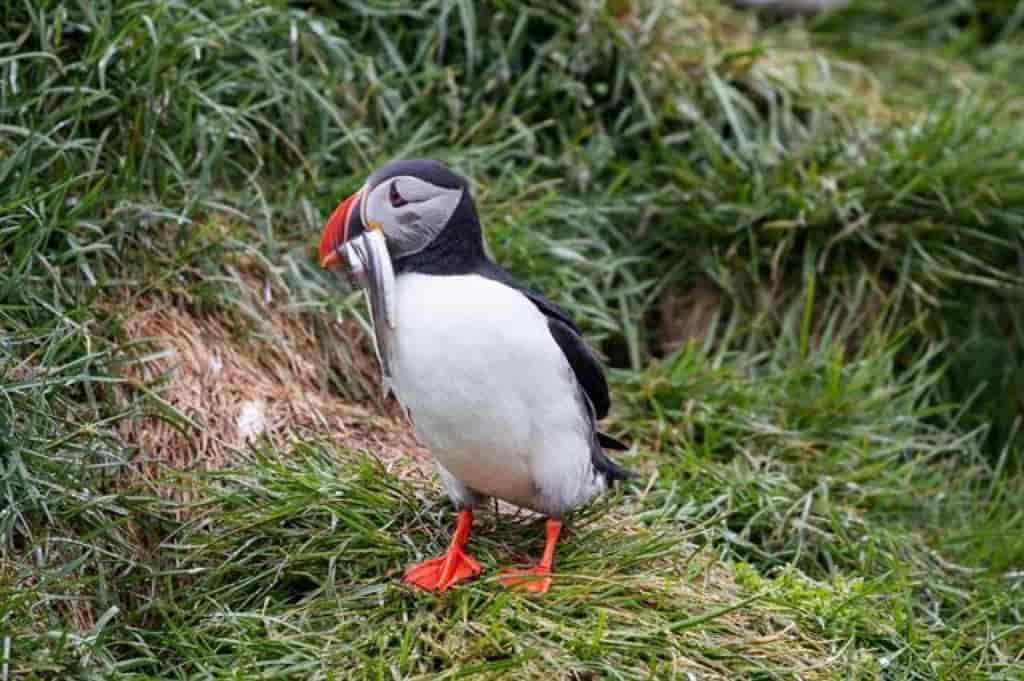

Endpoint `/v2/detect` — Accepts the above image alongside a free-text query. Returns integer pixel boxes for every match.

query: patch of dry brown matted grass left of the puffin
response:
[121,300,426,483]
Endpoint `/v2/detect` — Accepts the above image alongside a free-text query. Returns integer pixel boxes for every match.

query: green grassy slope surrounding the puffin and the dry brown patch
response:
[0,0,1024,679]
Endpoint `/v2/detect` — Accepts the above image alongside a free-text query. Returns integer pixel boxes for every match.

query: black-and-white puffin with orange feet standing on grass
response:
[319,159,635,593]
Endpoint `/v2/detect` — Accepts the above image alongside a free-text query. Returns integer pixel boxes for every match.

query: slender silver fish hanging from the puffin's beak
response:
[341,230,397,394]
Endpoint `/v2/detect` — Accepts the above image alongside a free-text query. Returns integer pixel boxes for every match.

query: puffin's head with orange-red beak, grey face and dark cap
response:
[319,159,467,267]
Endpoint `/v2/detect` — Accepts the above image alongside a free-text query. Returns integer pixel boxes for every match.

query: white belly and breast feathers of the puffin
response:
[392,274,603,513]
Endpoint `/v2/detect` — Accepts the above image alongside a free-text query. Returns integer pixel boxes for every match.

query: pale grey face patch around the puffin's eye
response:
[362,175,463,256]
